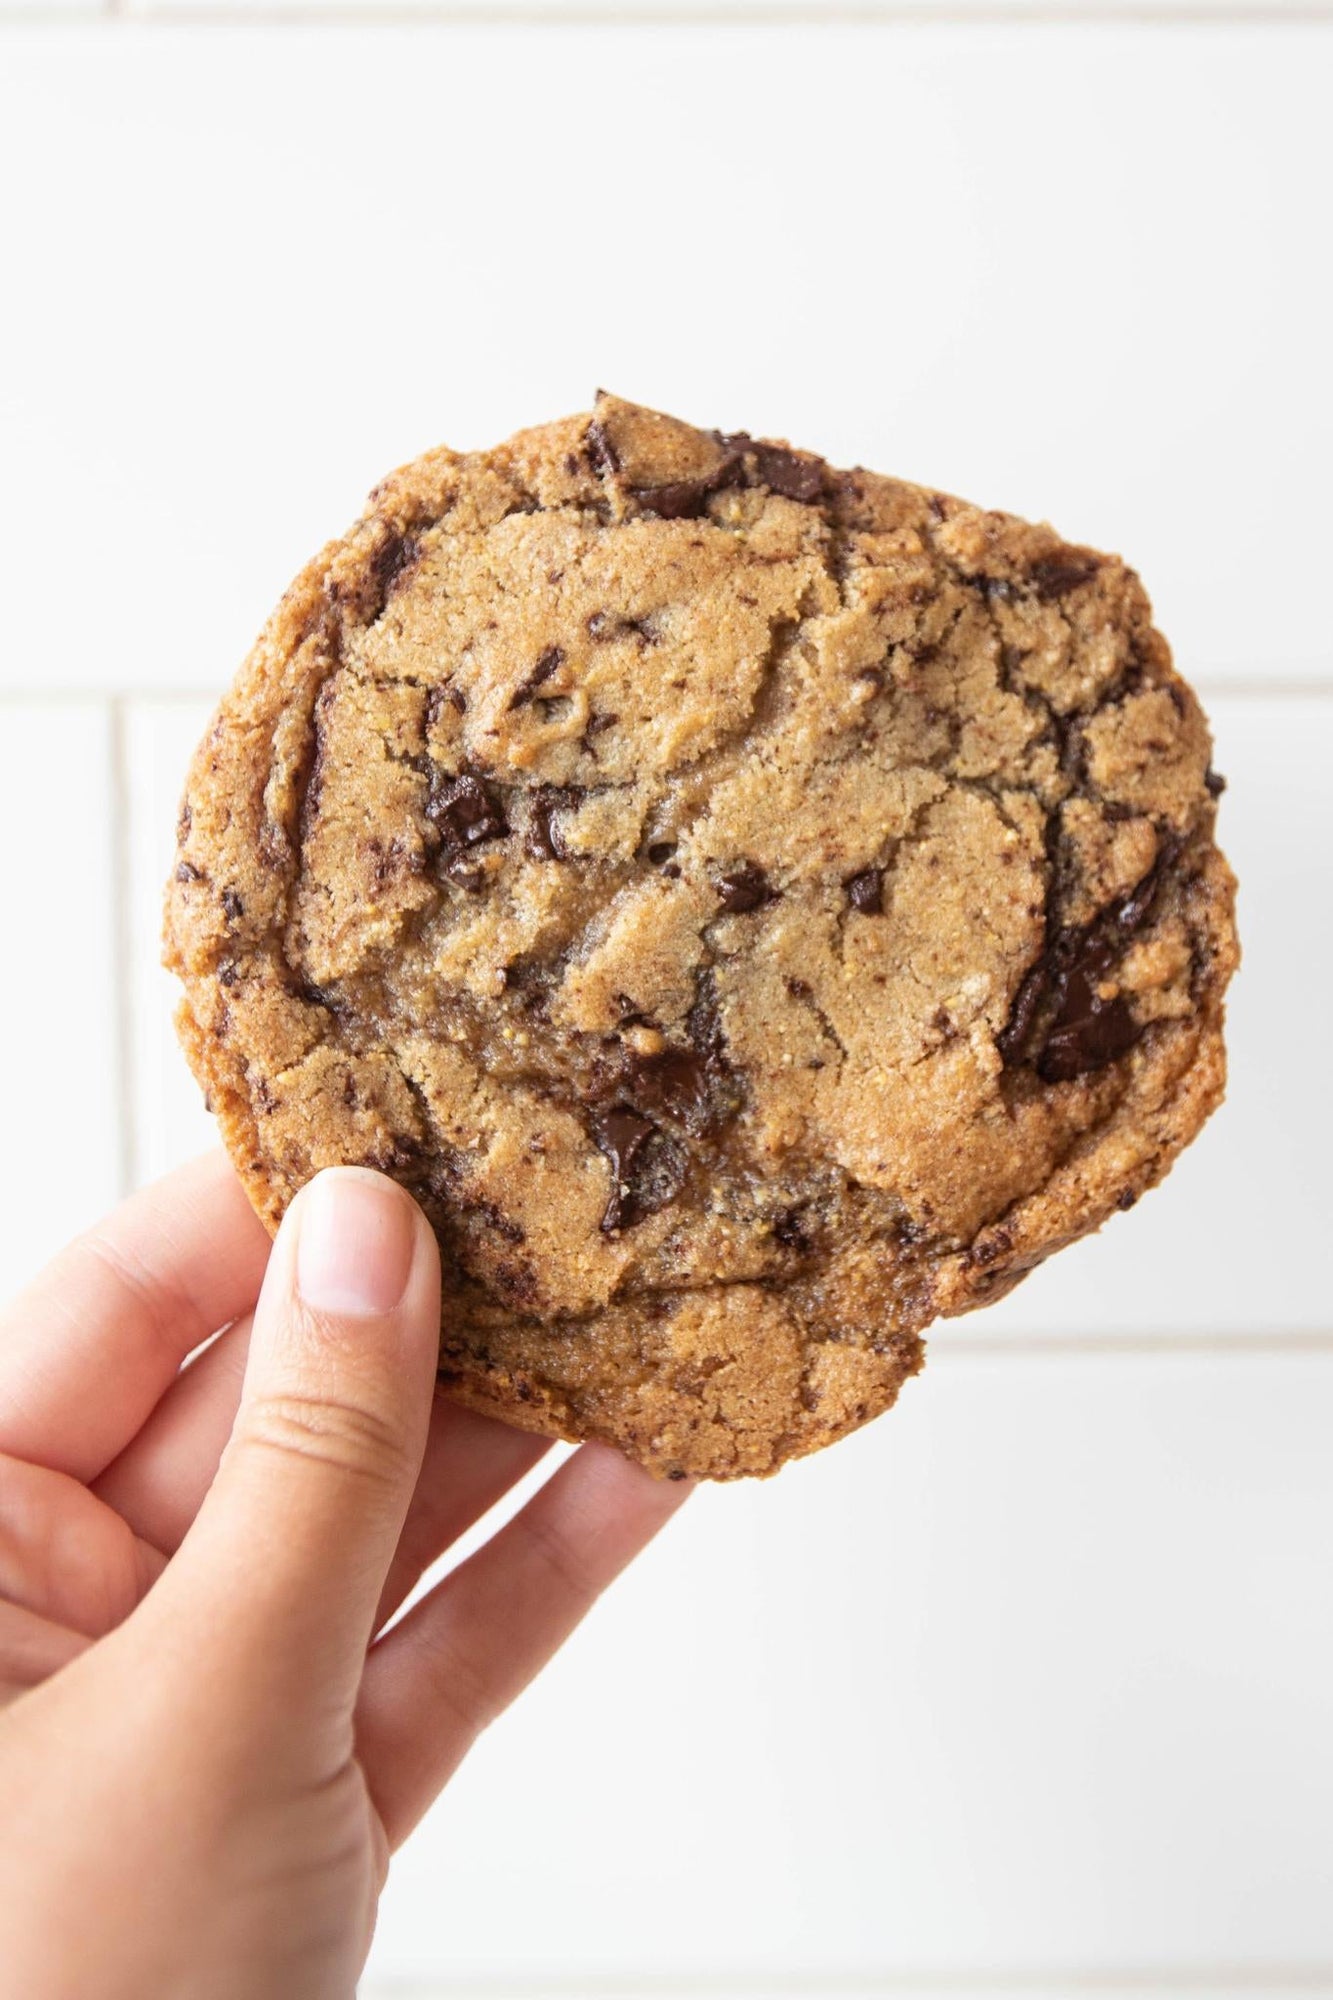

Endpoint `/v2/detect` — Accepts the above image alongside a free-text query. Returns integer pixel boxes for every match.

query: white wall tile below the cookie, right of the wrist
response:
[368,1352,1333,1996]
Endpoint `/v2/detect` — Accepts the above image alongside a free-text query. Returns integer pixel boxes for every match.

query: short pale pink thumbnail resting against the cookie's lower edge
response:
[296,1166,416,1316]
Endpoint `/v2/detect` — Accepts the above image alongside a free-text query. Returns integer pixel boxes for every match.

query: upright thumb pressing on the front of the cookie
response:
[164,1168,440,1700]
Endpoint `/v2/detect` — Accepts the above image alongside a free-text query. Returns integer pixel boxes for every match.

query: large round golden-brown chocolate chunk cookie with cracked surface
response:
[166,396,1237,1478]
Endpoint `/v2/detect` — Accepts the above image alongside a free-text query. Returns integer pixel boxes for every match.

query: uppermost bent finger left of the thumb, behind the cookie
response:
[0,1152,268,1480]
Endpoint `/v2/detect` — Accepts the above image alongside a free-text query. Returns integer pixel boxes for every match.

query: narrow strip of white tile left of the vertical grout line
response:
[0,700,122,1298]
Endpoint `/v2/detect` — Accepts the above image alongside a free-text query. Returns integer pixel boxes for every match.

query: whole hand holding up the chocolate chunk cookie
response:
[0,1156,689,2000]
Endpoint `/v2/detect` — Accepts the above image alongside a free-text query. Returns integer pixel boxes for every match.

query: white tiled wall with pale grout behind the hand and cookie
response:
[0,0,1333,2000]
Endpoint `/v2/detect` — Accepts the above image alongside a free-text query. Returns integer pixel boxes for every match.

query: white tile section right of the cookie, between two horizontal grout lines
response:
[933,696,1333,1342]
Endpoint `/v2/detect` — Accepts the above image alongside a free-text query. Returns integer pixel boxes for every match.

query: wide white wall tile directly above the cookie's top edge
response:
[0,22,1333,690]
